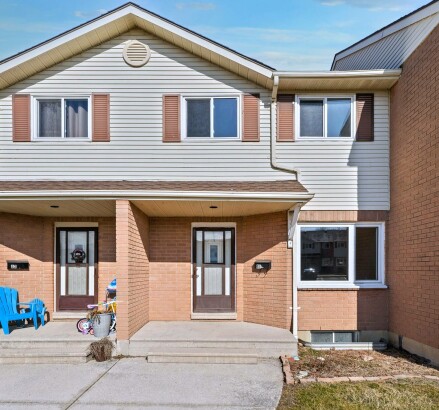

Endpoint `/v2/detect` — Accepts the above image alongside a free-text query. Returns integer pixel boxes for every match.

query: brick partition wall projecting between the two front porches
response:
[116,200,150,340]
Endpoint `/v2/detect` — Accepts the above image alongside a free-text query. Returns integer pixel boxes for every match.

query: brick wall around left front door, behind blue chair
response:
[0,213,116,312]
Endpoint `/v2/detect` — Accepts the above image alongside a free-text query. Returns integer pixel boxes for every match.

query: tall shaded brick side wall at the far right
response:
[387,27,439,348]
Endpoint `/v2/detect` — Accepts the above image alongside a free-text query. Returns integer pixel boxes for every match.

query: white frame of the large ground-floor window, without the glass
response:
[294,222,387,289]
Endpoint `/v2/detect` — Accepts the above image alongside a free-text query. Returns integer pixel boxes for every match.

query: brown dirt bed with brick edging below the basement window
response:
[289,347,439,377]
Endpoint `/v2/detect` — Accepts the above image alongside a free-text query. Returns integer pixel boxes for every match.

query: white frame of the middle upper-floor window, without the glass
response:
[180,94,242,142]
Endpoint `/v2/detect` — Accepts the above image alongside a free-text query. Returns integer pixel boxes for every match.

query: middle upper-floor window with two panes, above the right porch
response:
[182,97,240,139]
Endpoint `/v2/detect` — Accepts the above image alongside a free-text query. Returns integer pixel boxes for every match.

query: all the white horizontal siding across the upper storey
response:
[0,30,389,210]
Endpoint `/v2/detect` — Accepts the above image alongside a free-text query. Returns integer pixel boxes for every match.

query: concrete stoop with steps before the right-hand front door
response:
[124,322,297,364]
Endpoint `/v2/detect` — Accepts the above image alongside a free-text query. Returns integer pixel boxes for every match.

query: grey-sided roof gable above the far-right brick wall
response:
[331,0,439,71]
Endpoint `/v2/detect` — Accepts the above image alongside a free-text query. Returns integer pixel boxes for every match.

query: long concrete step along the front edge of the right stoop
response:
[129,340,297,358]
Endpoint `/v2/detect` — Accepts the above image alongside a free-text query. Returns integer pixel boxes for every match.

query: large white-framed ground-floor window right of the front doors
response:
[295,223,384,288]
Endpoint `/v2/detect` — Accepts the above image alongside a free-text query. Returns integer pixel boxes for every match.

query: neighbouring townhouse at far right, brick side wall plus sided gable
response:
[332,1,439,363]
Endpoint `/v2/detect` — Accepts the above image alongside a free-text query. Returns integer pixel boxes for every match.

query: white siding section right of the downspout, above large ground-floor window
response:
[277,91,390,210]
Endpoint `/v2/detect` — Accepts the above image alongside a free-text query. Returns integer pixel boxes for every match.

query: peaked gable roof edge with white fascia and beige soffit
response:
[0,2,274,89]
